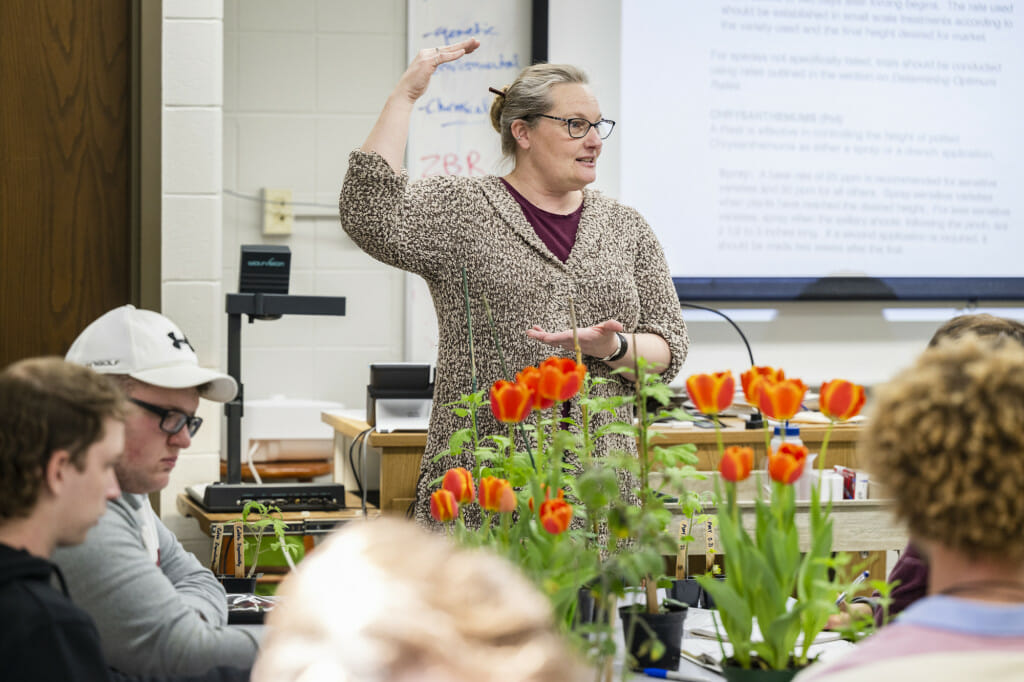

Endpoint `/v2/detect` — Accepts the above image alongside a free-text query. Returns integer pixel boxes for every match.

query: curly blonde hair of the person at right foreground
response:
[859,334,1024,563]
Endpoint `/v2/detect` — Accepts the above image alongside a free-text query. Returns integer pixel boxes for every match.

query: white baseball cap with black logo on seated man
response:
[65,305,239,402]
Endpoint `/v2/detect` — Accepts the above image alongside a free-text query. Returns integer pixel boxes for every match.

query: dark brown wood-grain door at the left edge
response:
[0,0,132,367]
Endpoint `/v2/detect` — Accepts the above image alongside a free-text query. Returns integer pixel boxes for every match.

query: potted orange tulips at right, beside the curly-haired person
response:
[687,368,863,679]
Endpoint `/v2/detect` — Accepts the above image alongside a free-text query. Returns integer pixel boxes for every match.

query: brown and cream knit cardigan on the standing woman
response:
[340,151,689,524]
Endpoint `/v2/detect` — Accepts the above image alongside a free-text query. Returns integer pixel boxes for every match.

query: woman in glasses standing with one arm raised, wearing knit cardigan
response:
[340,39,688,524]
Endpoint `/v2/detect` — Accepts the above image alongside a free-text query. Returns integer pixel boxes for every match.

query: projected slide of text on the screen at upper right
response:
[615,0,1024,278]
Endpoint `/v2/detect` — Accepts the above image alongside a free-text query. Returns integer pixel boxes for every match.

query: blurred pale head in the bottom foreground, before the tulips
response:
[252,518,585,682]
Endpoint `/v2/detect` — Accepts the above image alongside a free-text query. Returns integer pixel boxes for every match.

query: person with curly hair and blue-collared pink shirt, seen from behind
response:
[797,334,1024,682]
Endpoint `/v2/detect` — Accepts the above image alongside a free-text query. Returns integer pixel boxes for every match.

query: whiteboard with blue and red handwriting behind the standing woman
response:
[406,0,531,363]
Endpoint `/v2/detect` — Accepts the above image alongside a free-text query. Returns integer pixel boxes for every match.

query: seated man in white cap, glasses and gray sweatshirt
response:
[53,305,258,675]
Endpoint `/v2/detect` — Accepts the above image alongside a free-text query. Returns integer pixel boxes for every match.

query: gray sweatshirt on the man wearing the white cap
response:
[53,493,258,675]
